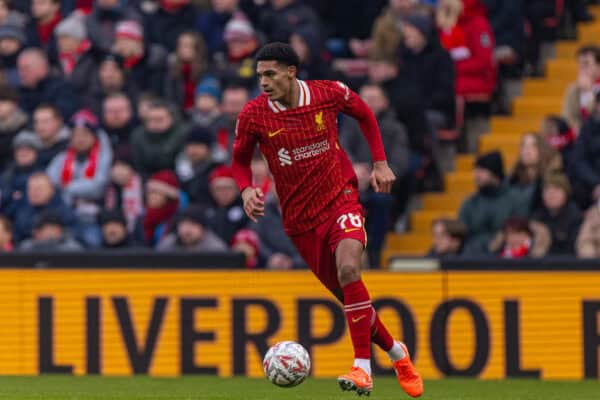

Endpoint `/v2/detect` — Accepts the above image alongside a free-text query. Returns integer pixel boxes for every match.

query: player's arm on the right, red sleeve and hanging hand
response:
[336,82,396,193]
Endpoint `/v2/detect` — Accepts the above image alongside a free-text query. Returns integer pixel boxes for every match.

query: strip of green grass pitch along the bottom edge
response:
[0,376,600,400]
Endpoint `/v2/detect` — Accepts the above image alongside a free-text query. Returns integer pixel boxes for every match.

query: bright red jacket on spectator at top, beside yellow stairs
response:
[440,0,497,101]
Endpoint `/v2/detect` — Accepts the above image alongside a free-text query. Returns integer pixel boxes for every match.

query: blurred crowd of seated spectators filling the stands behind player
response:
[0,0,600,269]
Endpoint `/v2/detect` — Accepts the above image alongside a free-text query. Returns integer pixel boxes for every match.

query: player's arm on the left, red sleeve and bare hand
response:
[231,110,265,222]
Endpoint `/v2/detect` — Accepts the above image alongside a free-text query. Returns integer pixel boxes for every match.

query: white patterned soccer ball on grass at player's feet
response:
[263,341,310,388]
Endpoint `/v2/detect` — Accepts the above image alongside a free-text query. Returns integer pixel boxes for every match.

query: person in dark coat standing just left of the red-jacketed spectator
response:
[400,15,456,130]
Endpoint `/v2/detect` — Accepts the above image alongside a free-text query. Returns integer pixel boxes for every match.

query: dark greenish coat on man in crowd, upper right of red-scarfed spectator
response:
[131,121,187,180]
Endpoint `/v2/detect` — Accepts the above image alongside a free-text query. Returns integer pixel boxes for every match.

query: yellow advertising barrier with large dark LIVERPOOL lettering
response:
[0,254,600,379]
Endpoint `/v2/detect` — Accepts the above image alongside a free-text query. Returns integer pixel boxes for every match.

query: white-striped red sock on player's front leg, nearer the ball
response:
[343,281,373,359]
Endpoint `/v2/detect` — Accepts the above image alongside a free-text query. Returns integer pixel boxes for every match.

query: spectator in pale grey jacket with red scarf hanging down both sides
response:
[47,110,112,247]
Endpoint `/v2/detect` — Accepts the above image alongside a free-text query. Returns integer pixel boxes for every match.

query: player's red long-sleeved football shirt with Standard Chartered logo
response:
[232,80,385,234]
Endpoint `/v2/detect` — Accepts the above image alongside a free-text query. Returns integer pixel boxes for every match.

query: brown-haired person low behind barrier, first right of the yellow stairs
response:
[428,218,467,258]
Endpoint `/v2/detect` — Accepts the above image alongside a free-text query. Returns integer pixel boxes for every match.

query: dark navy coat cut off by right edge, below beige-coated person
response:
[573,115,600,191]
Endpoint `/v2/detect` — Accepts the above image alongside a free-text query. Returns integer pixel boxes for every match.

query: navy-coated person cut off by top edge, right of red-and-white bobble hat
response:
[146,0,197,51]
